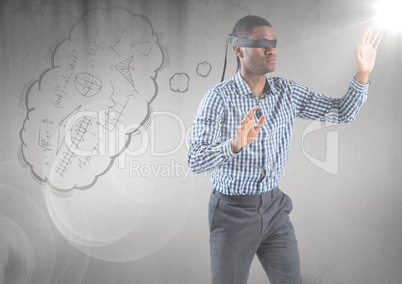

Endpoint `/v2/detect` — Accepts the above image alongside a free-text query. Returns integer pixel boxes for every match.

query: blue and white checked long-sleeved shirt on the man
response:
[188,72,368,195]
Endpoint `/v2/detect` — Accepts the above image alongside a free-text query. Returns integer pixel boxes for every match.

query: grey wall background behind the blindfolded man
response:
[0,0,402,284]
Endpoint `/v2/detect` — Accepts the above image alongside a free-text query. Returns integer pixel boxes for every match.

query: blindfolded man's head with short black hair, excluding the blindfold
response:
[232,15,276,75]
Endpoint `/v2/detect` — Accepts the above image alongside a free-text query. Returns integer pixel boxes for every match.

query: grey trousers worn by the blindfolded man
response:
[208,188,301,284]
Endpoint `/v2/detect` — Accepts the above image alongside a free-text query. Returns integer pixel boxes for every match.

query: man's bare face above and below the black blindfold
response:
[235,26,276,76]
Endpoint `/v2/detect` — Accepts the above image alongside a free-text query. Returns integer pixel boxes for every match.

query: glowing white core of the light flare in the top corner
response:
[376,0,402,32]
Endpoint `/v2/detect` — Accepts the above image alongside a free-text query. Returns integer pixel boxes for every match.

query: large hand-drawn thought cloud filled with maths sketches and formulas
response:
[20,7,165,193]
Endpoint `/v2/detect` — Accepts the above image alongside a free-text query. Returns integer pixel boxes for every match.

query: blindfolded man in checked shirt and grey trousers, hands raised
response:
[189,16,381,284]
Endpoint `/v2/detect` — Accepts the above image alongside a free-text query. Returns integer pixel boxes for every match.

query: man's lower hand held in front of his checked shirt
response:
[231,106,266,153]
